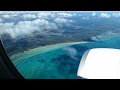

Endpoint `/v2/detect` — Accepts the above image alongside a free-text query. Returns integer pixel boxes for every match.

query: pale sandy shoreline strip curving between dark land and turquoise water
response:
[10,41,90,60]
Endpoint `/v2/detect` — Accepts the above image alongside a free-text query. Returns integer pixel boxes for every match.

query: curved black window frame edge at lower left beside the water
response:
[0,38,25,79]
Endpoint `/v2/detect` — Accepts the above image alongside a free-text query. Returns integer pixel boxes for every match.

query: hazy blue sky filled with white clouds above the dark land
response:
[0,11,120,39]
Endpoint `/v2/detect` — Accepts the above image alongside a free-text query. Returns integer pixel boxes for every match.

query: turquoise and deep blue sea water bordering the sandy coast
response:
[12,35,120,79]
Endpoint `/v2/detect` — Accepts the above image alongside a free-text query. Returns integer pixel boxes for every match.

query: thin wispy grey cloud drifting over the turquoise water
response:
[62,46,78,61]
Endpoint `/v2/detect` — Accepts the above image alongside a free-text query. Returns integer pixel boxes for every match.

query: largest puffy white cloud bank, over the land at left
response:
[0,19,57,39]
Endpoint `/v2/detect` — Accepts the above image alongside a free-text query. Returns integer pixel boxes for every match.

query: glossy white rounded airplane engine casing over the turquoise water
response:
[77,48,120,79]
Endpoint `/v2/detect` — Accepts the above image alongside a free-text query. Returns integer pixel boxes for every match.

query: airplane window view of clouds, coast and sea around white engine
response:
[0,11,120,79]
